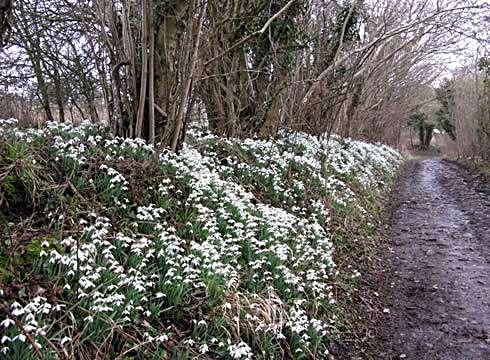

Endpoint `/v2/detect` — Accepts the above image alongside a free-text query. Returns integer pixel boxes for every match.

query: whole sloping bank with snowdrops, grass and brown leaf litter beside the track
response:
[0,120,401,359]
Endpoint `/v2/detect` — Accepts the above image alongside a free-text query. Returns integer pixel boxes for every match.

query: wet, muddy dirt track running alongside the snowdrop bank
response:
[379,159,490,360]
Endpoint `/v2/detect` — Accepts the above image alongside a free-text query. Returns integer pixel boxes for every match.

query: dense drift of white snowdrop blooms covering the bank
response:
[0,117,401,359]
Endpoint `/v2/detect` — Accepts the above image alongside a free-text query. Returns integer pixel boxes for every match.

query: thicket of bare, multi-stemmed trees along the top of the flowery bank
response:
[0,0,485,150]
